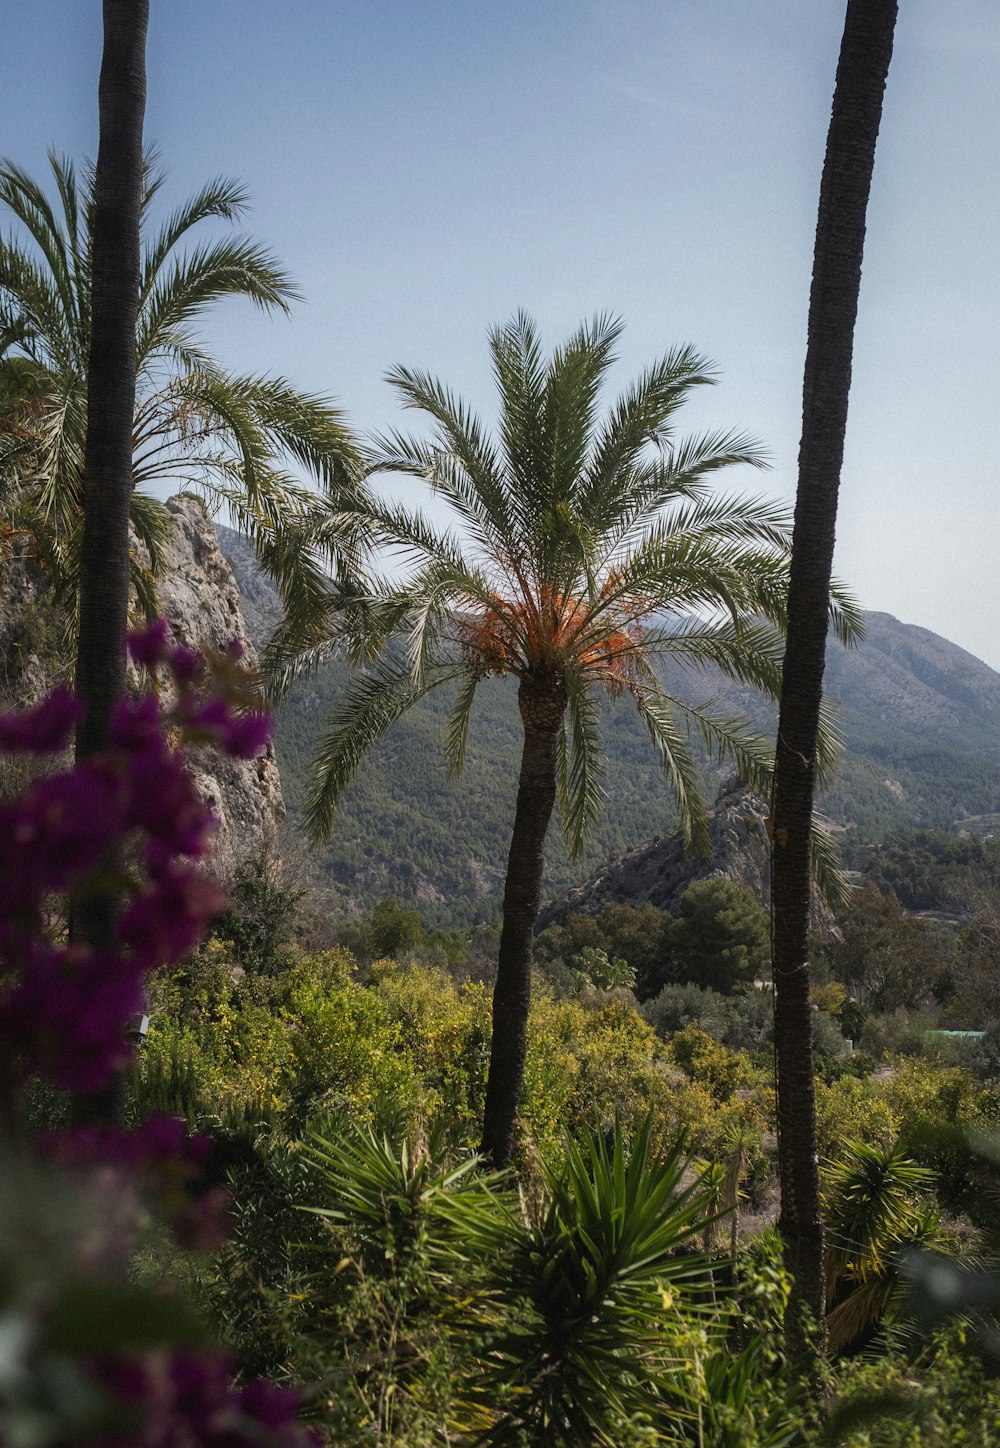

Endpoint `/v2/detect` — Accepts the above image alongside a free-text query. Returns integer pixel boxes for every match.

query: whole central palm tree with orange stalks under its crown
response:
[271,316,855,1167]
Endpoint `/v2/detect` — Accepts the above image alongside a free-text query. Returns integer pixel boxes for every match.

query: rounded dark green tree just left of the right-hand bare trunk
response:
[667,875,771,995]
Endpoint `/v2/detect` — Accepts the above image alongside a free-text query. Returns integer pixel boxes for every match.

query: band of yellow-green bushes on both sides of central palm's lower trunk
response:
[137,946,763,1157]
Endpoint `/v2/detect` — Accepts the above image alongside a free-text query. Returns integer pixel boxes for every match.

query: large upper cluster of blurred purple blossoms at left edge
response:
[0,620,268,1090]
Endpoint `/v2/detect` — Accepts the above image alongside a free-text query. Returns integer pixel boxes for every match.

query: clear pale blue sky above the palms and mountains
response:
[0,0,1000,669]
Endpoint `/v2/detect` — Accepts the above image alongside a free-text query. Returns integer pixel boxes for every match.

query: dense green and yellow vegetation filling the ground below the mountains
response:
[113,857,1000,1448]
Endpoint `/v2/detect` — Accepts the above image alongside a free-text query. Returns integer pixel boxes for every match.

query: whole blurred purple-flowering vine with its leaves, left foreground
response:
[0,620,314,1448]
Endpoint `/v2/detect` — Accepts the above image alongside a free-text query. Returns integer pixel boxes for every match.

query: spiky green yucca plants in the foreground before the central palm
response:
[238,1121,795,1448]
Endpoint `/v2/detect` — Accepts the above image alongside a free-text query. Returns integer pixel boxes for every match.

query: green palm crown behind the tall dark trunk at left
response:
[0,149,362,637]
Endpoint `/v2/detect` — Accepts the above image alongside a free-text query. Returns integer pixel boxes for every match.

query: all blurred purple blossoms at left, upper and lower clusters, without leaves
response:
[0,620,318,1448]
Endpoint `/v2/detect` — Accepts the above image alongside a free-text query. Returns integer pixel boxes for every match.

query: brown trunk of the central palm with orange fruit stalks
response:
[482,675,566,1169]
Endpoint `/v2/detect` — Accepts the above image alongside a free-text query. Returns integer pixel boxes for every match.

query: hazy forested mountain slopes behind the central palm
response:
[219,529,1000,924]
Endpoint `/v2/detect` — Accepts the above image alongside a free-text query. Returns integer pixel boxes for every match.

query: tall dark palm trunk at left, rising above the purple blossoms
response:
[72,0,149,1115]
